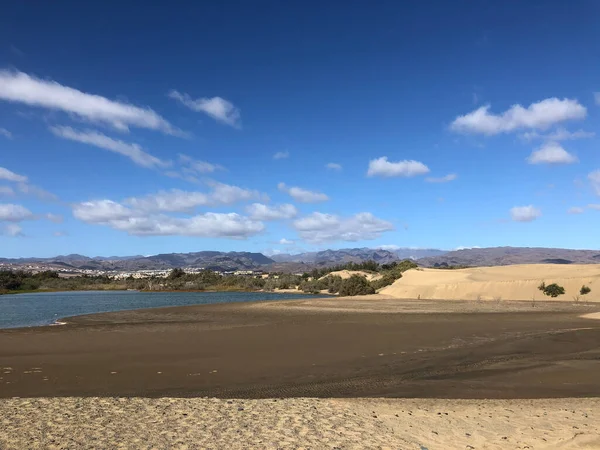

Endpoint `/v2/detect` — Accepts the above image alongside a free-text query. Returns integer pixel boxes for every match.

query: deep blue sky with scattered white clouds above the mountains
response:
[0,0,600,257]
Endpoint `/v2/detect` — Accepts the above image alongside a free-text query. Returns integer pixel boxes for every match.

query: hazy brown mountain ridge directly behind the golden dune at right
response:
[418,247,600,267]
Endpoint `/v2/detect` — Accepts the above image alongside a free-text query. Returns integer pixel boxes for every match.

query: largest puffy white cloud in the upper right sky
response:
[450,98,587,136]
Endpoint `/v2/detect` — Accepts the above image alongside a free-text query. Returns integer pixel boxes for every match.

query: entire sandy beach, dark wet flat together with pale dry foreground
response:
[0,295,600,450]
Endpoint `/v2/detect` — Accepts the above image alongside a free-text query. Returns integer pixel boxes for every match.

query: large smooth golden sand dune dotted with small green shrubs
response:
[380,264,600,301]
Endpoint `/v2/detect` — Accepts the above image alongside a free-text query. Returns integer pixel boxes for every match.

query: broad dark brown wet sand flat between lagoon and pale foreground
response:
[0,298,600,398]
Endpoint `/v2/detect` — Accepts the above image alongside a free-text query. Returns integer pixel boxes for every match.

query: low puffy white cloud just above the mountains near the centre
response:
[293,212,394,243]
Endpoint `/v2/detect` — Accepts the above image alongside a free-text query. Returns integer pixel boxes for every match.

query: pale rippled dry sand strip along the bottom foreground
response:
[0,397,600,450]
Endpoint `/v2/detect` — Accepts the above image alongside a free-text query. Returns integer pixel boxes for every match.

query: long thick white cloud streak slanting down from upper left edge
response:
[0,70,182,135]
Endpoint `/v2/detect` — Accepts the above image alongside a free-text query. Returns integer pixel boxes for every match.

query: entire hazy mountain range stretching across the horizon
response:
[0,247,600,272]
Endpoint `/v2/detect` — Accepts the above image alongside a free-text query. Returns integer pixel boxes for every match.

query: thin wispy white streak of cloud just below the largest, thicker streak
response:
[50,127,169,169]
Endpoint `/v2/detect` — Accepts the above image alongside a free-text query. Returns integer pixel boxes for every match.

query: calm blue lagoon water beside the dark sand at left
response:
[0,291,314,328]
